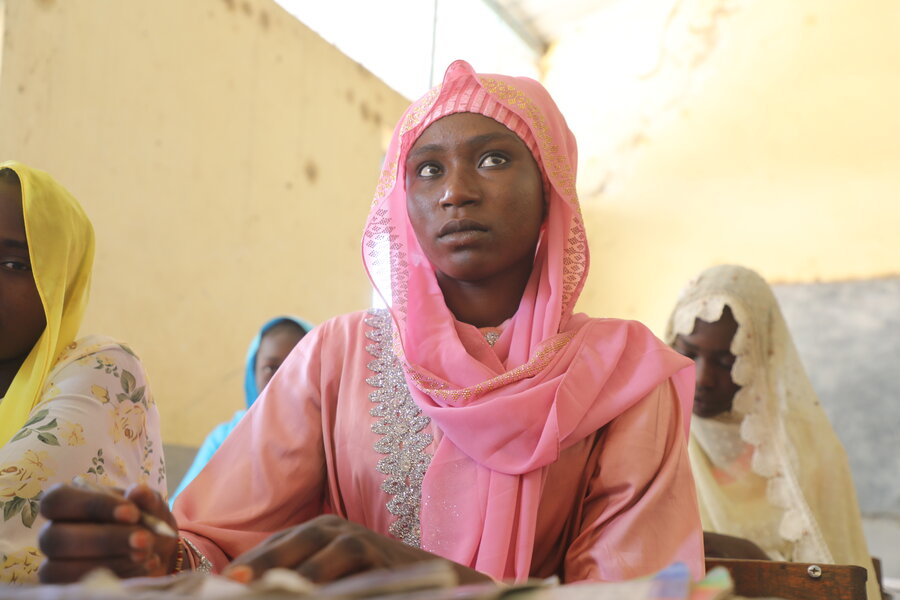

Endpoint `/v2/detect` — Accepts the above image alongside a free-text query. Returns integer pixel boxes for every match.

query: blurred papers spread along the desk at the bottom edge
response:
[0,561,732,600]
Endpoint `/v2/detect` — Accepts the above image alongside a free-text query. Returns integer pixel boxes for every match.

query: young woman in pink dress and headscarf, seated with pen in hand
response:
[42,62,703,582]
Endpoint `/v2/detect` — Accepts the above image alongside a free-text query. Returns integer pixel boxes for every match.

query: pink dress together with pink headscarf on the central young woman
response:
[175,61,703,581]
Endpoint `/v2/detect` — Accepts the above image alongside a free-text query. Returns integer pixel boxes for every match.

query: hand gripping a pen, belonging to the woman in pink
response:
[38,485,178,583]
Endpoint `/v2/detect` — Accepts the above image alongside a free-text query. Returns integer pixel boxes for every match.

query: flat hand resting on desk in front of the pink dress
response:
[224,515,491,583]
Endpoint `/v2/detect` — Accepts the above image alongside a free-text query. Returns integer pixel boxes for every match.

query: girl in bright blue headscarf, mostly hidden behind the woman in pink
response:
[169,317,312,506]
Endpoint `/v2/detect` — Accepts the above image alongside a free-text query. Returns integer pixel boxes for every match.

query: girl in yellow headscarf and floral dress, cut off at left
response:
[0,162,166,582]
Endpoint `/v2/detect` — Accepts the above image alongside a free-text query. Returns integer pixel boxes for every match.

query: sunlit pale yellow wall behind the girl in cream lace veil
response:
[545,0,900,332]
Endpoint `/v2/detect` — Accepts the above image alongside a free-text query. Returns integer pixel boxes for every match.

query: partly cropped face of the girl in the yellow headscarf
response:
[0,180,47,361]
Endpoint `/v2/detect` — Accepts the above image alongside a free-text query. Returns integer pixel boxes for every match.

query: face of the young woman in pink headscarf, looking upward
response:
[406,113,545,282]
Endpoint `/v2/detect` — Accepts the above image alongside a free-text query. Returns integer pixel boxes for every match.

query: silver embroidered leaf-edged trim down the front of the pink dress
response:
[365,309,433,548]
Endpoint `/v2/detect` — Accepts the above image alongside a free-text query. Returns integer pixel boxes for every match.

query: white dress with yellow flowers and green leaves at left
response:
[0,336,166,583]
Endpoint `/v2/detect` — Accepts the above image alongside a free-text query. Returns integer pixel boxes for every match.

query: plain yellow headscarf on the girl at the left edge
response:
[0,161,94,446]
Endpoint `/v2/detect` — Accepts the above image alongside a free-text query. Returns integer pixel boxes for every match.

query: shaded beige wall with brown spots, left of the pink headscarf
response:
[0,0,406,444]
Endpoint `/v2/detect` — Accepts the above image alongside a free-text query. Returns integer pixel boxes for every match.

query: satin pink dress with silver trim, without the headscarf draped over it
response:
[175,312,703,582]
